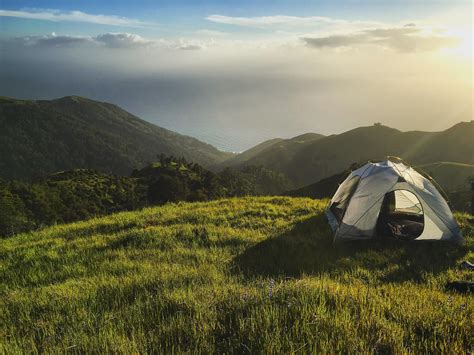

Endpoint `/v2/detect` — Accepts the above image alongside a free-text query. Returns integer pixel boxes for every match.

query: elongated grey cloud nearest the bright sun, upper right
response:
[302,24,459,52]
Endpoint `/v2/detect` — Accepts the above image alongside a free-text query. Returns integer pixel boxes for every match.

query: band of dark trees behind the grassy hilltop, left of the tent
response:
[0,156,291,236]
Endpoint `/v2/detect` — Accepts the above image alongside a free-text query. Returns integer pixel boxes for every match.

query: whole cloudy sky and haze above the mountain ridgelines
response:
[0,0,473,151]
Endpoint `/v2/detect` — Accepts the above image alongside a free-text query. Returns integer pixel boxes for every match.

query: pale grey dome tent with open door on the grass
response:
[326,157,462,241]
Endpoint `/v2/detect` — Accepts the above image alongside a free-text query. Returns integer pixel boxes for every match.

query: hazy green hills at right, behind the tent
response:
[226,121,474,186]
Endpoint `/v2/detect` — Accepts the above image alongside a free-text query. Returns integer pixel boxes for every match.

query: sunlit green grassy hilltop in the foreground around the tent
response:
[0,197,474,354]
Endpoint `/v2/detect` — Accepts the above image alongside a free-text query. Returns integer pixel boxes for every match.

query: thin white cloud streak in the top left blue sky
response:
[0,10,156,27]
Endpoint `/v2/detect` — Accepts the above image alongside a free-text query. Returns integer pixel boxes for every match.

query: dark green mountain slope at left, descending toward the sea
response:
[0,96,230,179]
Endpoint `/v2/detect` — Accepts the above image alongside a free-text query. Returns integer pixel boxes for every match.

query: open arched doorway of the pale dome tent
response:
[376,190,425,240]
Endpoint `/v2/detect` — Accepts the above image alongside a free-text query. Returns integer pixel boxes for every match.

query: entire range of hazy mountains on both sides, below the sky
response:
[0,96,474,189]
